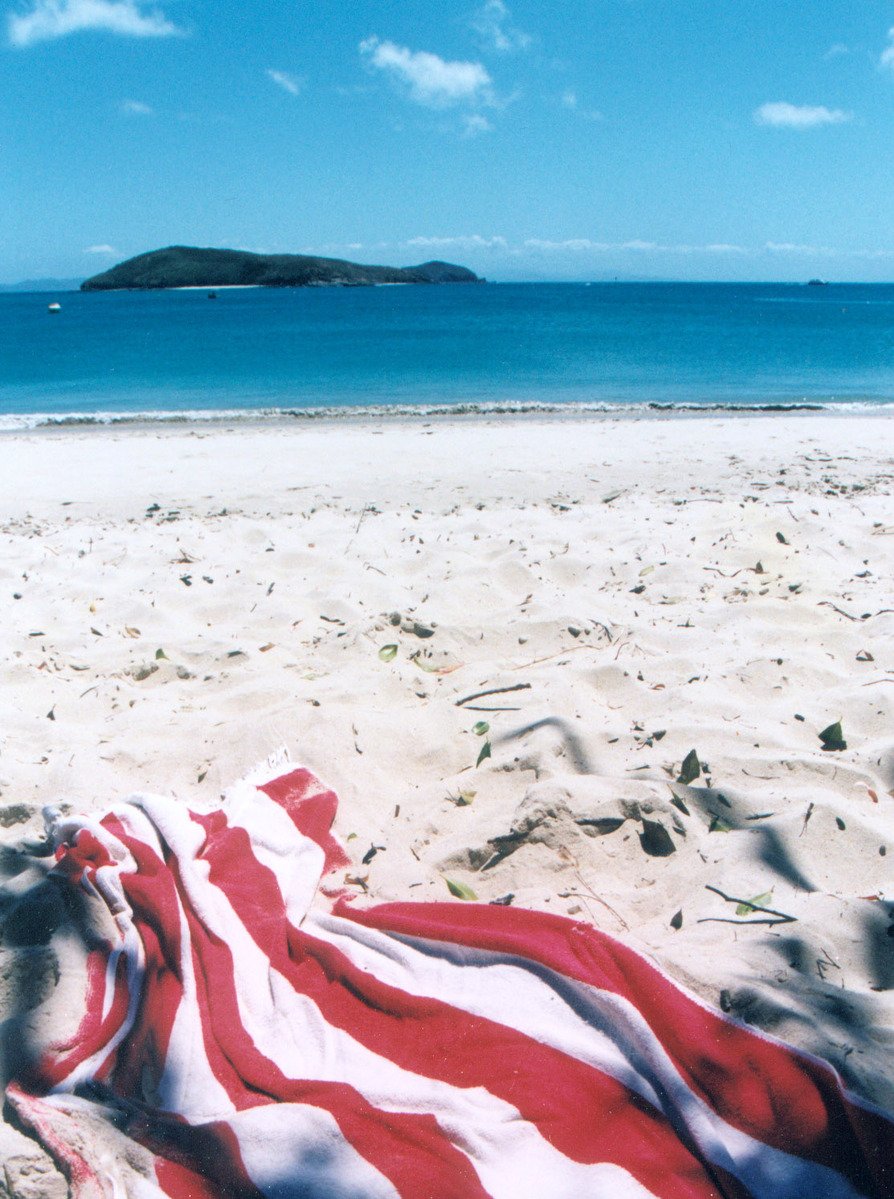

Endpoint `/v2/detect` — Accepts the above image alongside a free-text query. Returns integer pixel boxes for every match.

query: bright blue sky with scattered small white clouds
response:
[0,0,894,282]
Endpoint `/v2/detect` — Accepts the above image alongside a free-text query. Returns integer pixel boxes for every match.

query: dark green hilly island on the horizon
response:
[80,246,484,291]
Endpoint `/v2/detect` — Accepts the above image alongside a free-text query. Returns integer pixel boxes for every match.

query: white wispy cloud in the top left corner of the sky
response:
[7,0,182,47]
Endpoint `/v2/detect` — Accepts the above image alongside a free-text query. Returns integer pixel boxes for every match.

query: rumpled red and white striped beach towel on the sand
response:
[7,769,894,1199]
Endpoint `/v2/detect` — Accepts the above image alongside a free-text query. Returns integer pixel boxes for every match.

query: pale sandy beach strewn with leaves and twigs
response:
[0,414,894,1195]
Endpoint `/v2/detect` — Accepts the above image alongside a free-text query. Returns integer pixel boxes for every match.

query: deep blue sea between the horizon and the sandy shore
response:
[0,283,894,429]
